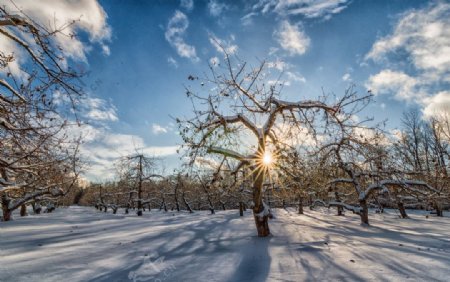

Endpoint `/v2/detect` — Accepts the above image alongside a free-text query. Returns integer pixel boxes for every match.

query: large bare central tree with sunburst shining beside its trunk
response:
[177,50,370,237]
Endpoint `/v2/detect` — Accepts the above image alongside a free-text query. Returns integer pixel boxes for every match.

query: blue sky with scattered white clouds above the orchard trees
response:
[0,0,450,180]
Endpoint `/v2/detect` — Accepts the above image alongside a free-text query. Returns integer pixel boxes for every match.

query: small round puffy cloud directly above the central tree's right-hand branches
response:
[274,20,311,55]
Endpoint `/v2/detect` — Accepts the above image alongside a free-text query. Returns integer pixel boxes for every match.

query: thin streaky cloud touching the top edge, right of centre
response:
[253,0,351,19]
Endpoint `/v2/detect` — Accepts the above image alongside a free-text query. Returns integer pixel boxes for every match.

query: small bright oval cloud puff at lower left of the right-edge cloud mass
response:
[365,70,423,100]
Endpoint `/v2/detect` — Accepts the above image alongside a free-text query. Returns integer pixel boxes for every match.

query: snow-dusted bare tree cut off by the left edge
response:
[0,6,83,220]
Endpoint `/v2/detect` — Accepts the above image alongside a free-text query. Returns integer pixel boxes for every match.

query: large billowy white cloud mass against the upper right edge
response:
[365,1,450,115]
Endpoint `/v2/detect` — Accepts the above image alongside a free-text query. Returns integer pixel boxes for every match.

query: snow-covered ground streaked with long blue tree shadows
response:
[0,207,450,281]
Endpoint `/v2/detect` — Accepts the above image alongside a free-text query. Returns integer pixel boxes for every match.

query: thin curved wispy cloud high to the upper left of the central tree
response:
[165,10,199,62]
